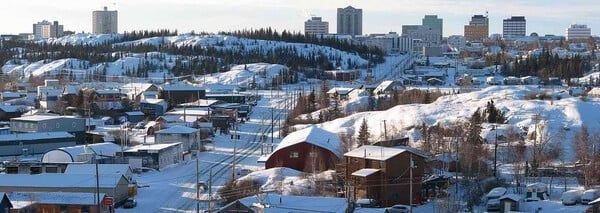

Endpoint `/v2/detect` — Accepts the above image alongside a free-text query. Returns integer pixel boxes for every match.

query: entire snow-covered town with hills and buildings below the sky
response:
[0,0,600,213]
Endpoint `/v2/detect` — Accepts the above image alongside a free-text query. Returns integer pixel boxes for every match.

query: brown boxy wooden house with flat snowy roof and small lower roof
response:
[344,145,427,206]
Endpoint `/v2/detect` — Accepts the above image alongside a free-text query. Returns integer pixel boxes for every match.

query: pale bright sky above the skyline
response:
[0,0,600,37]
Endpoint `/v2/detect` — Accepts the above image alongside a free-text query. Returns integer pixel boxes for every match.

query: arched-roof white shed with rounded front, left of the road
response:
[42,143,121,163]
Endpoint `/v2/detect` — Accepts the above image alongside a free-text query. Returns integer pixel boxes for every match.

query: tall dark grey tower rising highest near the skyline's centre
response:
[337,6,362,36]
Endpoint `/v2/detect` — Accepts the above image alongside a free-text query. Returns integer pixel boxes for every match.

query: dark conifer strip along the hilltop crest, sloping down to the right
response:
[220,27,385,63]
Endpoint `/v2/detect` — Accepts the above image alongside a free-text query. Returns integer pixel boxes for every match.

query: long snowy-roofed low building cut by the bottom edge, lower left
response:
[7,192,107,212]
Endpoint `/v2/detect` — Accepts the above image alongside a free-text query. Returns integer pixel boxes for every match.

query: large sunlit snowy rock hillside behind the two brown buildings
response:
[308,86,600,159]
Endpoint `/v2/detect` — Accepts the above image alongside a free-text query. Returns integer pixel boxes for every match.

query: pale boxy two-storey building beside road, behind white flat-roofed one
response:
[156,126,200,151]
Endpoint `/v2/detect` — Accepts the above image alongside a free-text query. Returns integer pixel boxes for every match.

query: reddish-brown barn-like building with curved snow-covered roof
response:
[265,126,343,172]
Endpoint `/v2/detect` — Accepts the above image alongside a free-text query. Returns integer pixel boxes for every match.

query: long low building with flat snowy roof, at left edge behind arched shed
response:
[0,132,76,156]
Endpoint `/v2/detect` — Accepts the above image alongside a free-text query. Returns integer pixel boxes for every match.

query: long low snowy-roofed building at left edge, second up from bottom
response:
[0,173,130,203]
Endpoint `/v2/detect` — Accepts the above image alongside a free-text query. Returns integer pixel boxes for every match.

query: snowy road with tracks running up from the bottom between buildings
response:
[117,91,289,212]
